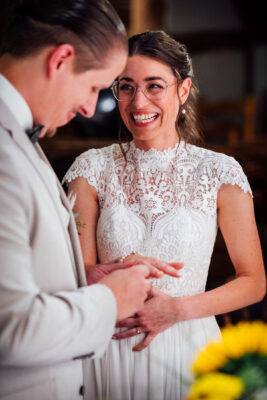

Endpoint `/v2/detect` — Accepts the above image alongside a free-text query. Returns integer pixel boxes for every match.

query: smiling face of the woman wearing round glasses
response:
[118,55,188,147]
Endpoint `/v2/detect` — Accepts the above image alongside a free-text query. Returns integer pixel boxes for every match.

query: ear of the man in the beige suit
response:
[48,44,74,79]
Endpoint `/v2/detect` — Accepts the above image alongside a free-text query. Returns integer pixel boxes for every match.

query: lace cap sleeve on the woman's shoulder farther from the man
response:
[217,156,253,197]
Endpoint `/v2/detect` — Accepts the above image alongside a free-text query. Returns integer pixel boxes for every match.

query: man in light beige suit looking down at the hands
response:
[0,0,150,400]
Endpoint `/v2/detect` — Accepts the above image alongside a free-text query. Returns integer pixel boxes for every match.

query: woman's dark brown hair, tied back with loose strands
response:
[119,31,201,153]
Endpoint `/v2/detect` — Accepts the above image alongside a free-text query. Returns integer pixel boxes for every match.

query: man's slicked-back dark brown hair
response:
[0,0,128,72]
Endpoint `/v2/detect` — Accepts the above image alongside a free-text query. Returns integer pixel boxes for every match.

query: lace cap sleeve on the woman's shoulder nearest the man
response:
[62,149,102,190]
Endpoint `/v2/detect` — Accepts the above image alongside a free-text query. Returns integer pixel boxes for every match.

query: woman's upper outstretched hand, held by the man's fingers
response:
[123,253,184,278]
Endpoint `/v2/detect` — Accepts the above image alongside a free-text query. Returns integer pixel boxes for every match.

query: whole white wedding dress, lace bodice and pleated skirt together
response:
[65,142,251,400]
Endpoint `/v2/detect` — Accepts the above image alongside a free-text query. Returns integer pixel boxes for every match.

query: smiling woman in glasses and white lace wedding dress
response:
[65,31,265,400]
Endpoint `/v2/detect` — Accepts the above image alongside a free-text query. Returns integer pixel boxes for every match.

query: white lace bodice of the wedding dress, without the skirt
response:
[64,142,251,296]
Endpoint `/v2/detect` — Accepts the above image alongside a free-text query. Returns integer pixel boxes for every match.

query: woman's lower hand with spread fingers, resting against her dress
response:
[113,288,179,351]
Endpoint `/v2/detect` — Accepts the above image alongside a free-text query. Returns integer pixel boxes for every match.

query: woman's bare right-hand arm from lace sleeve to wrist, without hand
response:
[177,185,266,319]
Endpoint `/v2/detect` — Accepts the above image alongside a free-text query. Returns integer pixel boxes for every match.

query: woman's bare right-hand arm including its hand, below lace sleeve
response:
[115,185,266,350]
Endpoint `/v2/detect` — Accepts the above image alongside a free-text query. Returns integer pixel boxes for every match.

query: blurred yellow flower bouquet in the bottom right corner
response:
[187,321,267,400]
